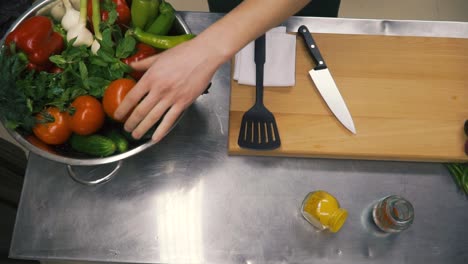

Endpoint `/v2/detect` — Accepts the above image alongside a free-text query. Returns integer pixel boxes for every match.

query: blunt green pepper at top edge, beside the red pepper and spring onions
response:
[130,0,159,28]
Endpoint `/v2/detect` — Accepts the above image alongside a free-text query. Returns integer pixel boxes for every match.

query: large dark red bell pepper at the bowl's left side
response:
[5,16,64,71]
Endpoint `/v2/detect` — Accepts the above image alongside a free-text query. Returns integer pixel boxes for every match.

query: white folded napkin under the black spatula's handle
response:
[233,27,296,86]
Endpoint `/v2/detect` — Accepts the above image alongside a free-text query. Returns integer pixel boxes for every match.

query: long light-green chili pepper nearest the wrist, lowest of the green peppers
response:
[132,28,195,49]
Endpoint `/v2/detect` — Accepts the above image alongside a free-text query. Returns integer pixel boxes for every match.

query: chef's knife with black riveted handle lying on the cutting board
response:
[298,25,356,134]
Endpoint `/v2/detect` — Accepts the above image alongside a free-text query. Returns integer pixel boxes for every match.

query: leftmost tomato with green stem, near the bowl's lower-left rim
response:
[33,107,72,145]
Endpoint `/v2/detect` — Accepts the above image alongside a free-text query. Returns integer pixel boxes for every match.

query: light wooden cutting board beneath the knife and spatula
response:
[228,33,468,162]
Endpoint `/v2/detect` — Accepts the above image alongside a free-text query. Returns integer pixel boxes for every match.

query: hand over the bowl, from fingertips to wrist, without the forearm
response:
[115,38,223,142]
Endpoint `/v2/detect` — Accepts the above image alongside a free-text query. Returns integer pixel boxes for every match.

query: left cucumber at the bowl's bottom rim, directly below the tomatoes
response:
[70,134,117,157]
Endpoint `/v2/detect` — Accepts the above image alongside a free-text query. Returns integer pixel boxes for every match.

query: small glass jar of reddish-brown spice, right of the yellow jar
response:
[372,195,414,233]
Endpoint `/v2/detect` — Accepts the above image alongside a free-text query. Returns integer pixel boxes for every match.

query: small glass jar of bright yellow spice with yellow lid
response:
[301,191,348,233]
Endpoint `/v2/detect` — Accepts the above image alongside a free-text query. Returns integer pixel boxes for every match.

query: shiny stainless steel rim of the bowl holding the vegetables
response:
[1,0,191,168]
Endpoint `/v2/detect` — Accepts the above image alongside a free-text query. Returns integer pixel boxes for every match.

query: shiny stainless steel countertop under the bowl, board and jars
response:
[10,12,468,263]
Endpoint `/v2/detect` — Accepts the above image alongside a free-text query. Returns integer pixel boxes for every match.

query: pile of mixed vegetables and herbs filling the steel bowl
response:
[0,0,195,157]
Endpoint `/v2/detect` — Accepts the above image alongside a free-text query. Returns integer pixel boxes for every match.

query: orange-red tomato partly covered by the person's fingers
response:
[102,78,136,122]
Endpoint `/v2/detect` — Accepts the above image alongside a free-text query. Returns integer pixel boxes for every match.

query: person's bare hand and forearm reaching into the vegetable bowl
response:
[114,0,310,142]
